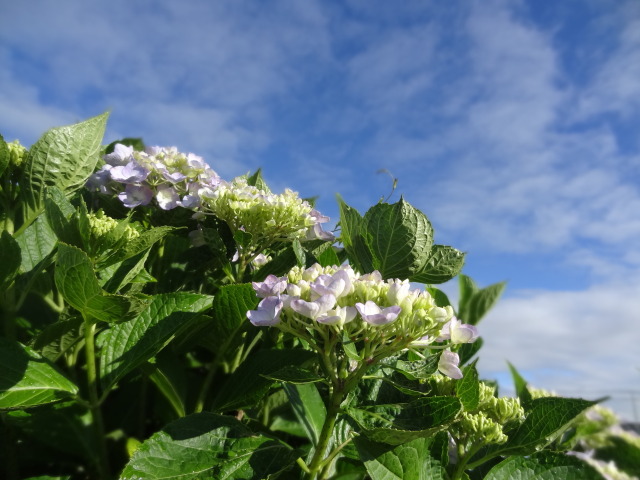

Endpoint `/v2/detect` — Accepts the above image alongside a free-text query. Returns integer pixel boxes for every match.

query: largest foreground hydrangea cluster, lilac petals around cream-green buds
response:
[247,264,478,378]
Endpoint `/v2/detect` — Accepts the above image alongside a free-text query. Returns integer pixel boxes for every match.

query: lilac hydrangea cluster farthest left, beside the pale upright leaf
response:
[87,143,221,210]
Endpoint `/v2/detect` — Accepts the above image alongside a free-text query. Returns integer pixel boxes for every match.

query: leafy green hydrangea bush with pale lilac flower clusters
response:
[0,115,640,480]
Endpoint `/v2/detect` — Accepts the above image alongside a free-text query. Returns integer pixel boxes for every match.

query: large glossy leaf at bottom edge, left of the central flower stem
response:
[120,412,299,480]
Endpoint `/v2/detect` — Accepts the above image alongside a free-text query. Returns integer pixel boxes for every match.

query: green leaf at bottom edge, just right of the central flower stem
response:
[354,437,448,480]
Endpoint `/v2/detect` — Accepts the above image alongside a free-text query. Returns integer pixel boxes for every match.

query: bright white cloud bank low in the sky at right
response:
[479,282,640,418]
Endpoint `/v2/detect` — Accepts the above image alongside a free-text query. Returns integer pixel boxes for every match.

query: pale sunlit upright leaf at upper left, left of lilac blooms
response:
[21,113,108,212]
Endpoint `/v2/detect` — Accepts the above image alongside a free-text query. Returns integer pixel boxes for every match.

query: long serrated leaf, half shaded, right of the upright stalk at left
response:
[97,292,212,390]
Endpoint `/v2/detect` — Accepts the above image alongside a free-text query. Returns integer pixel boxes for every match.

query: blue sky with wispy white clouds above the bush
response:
[0,0,640,418]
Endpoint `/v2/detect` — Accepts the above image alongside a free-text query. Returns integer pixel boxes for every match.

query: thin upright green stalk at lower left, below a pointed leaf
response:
[84,317,109,478]
